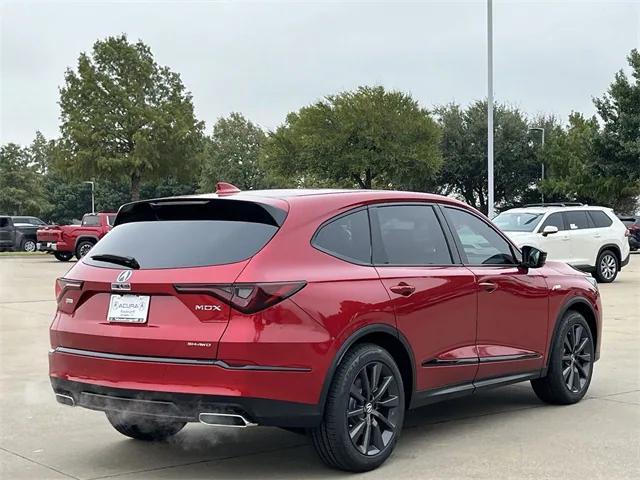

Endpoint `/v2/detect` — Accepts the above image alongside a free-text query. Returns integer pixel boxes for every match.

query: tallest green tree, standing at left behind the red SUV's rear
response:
[59,35,203,200]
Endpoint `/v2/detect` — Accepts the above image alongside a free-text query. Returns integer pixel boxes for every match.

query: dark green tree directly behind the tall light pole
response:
[436,101,540,213]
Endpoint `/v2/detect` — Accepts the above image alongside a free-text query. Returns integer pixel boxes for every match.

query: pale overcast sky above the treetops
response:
[0,0,640,143]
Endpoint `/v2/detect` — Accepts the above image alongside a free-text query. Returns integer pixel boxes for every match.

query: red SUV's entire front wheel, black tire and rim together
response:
[531,310,595,405]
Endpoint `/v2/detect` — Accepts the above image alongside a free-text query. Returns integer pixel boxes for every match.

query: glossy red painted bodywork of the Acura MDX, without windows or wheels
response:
[50,191,601,414]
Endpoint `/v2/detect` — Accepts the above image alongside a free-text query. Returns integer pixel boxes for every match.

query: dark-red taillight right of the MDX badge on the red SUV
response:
[174,282,307,314]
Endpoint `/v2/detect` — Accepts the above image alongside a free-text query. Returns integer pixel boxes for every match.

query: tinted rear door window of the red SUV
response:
[374,205,453,265]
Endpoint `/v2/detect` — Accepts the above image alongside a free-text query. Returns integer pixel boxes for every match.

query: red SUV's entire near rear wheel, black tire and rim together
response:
[310,343,405,472]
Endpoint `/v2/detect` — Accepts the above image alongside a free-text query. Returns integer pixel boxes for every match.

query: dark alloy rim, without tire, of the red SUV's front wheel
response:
[562,324,592,393]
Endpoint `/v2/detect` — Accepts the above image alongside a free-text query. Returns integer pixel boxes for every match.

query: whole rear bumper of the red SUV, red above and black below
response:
[49,350,324,427]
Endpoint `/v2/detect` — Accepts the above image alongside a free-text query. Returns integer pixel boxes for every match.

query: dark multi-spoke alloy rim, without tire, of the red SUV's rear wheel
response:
[346,362,400,455]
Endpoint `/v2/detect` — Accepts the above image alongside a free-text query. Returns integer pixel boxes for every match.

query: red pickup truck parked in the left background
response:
[37,213,116,262]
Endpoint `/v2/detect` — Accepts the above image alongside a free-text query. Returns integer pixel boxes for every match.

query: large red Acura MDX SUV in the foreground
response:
[49,186,601,471]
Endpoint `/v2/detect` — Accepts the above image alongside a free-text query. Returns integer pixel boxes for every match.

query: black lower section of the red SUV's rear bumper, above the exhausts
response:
[51,377,321,428]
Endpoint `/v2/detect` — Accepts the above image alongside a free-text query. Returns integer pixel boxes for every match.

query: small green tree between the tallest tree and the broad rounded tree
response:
[200,113,266,192]
